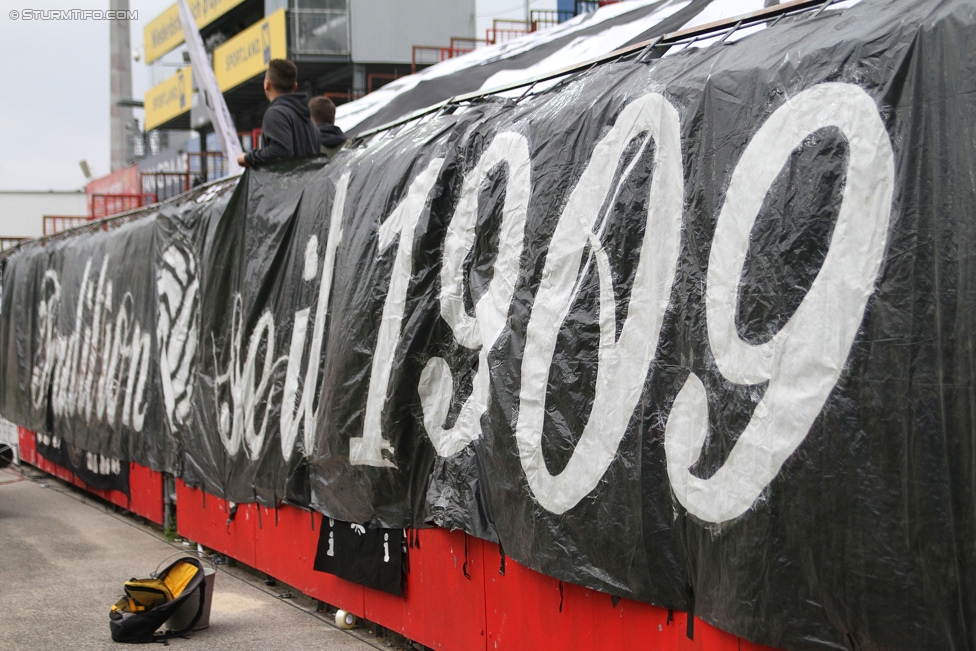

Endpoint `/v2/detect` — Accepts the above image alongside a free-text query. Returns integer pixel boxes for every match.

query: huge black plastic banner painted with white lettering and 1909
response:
[0,0,976,649]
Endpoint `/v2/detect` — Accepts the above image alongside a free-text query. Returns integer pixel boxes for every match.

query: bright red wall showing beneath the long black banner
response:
[20,428,768,651]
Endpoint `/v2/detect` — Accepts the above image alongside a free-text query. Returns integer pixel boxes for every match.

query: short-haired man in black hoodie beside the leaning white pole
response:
[237,59,320,167]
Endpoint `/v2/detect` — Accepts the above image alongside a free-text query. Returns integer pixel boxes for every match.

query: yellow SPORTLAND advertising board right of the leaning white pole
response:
[214,9,288,91]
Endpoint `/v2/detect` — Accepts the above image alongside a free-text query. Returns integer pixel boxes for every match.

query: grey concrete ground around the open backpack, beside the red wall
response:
[0,466,402,651]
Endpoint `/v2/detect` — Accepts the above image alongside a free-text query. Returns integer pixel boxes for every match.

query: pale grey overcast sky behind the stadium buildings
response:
[0,0,556,190]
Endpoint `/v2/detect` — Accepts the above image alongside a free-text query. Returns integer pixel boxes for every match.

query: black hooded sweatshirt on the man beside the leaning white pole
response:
[244,93,320,167]
